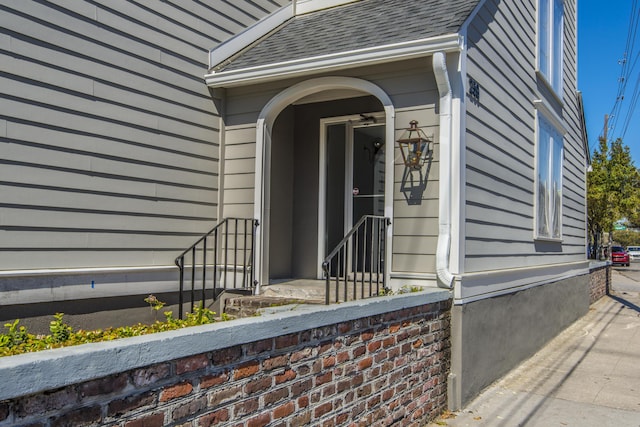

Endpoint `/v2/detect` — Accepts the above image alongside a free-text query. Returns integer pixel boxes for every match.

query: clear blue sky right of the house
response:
[578,0,640,167]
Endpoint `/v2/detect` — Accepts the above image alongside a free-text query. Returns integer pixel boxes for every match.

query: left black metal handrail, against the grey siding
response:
[175,218,258,319]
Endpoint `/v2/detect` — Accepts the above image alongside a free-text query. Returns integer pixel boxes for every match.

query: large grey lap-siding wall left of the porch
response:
[0,0,288,270]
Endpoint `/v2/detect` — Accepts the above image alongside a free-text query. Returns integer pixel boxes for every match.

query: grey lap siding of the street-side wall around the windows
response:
[465,0,585,272]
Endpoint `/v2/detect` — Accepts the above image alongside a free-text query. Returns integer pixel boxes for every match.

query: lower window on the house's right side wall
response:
[533,102,566,242]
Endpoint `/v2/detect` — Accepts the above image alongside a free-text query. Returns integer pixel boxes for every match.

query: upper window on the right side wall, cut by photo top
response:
[536,0,564,97]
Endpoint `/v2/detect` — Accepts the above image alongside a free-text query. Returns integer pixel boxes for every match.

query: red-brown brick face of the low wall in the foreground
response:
[0,295,451,427]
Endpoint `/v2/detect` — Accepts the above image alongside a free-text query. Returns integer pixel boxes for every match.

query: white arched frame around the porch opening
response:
[253,77,395,293]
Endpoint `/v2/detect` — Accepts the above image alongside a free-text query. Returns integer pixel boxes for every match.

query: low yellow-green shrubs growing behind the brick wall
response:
[0,295,229,357]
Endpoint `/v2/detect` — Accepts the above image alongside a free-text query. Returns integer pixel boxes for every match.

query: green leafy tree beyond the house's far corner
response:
[587,137,640,257]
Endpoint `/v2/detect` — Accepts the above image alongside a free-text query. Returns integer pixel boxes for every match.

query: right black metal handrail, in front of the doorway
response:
[322,215,391,304]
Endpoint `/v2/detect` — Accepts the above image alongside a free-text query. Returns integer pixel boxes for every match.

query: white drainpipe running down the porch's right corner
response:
[433,52,455,289]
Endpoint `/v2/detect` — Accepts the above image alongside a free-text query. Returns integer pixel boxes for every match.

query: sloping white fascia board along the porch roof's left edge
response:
[209,2,295,70]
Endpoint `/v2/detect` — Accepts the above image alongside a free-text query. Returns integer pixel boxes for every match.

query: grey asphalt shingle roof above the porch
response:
[216,0,479,71]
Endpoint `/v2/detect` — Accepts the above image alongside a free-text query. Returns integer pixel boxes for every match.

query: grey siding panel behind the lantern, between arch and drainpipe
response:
[371,58,440,273]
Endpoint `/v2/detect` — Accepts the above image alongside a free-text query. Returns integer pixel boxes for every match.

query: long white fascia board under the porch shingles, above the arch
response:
[204,33,464,87]
